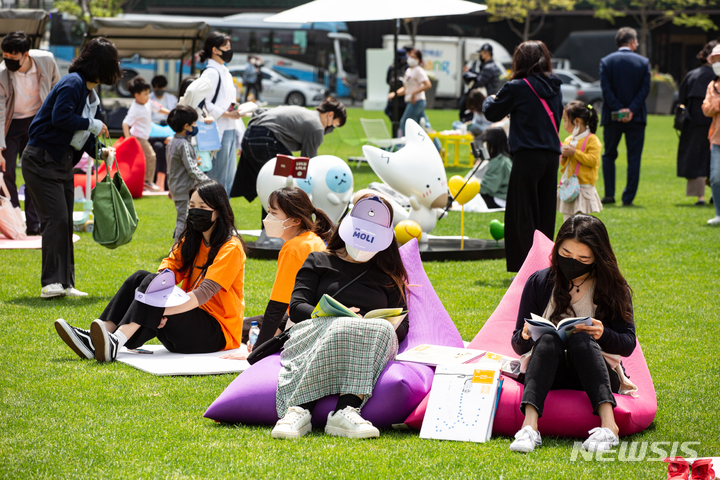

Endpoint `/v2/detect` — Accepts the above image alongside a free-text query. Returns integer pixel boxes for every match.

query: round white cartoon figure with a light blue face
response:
[306,155,354,222]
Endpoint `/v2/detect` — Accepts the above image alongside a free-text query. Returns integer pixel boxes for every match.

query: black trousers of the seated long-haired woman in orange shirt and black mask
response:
[100,270,225,353]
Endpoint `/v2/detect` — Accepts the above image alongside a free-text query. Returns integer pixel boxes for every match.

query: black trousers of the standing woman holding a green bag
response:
[22,146,75,288]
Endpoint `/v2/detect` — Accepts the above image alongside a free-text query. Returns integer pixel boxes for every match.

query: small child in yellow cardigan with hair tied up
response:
[557,100,602,220]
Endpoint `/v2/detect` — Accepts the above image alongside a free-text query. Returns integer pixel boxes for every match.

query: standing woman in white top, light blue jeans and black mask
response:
[200,32,240,195]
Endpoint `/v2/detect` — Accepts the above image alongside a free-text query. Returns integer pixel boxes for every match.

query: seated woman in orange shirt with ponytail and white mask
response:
[222,187,334,359]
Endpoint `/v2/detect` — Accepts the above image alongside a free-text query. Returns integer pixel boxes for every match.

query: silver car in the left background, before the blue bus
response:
[230,65,327,106]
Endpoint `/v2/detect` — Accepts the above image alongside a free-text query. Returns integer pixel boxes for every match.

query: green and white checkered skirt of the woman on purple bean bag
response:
[276,317,398,417]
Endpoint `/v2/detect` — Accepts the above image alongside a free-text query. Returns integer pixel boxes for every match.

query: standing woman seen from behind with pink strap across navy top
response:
[483,40,563,272]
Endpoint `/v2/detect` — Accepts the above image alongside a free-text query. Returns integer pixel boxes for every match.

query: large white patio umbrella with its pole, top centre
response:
[264,0,487,135]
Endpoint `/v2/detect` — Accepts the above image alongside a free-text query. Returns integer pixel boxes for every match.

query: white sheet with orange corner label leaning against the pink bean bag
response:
[420,361,500,442]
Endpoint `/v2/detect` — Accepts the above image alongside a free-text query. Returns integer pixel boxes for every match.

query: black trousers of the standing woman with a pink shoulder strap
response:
[505,150,560,272]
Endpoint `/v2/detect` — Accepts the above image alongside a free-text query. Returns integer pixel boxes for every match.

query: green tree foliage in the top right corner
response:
[592,0,718,56]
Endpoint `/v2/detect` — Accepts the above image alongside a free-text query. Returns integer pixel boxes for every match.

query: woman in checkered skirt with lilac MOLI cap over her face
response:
[272,195,408,438]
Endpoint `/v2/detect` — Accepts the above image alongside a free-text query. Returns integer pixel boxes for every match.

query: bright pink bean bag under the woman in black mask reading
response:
[405,231,657,438]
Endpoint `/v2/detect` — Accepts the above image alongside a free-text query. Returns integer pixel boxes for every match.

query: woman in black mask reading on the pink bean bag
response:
[510,215,635,452]
